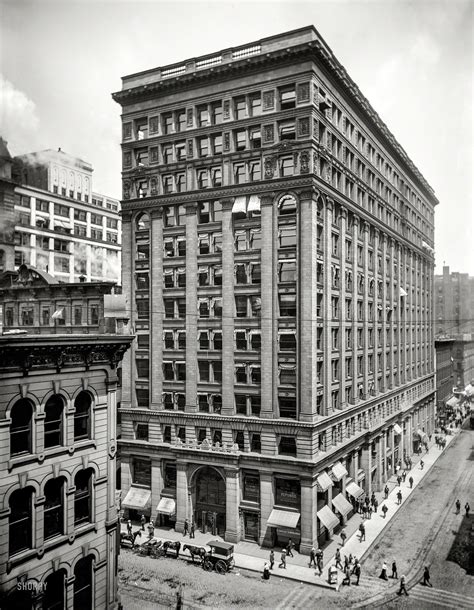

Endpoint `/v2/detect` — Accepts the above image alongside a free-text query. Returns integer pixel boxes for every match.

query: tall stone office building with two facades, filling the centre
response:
[113,27,437,552]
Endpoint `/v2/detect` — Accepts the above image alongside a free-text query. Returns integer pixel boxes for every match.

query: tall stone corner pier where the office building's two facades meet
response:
[297,190,318,421]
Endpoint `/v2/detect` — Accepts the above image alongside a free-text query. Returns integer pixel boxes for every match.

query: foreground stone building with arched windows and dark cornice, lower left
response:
[0,334,132,610]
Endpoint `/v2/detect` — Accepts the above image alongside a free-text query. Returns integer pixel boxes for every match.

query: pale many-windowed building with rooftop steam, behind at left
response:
[0,150,121,282]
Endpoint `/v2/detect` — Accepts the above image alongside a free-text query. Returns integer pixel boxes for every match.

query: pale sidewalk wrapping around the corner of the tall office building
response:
[121,426,456,589]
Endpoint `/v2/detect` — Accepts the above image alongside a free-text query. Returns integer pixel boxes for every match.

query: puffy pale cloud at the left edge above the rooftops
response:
[0,74,39,154]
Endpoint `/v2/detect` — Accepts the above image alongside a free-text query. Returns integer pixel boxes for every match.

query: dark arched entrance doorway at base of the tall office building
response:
[194,466,226,536]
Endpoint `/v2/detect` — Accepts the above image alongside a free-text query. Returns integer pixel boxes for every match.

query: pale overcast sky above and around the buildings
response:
[0,0,474,275]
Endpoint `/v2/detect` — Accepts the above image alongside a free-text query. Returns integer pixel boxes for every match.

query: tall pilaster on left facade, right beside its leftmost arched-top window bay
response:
[149,208,163,409]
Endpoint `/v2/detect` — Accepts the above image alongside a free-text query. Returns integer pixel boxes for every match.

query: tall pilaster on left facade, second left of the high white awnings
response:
[185,203,198,413]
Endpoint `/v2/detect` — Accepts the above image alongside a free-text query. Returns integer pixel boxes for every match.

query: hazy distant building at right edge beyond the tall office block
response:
[434,266,474,337]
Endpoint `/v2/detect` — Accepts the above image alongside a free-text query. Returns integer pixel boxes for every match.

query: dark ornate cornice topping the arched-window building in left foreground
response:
[0,335,134,375]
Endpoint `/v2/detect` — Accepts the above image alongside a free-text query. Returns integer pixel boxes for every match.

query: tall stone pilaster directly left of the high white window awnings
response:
[221,198,235,415]
